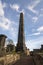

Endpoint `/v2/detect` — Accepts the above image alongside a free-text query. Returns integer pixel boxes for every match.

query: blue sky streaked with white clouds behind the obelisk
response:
[0,0,43,50]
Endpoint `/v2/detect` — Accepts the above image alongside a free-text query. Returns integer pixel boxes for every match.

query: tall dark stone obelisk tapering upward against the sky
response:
[16,13,26,52]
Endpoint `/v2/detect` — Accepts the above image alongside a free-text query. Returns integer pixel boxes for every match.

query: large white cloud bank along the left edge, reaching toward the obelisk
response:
[0,0,18,44]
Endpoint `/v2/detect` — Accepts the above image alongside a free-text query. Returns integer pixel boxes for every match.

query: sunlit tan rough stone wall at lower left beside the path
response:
[0,54,20,65]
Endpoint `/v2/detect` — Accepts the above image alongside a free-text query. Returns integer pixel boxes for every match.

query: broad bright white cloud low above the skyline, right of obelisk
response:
[26,37,43,50]
